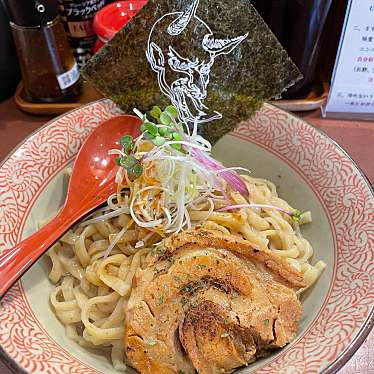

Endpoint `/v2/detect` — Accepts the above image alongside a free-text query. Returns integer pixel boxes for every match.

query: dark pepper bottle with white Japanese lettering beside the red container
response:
[58,0,108,67]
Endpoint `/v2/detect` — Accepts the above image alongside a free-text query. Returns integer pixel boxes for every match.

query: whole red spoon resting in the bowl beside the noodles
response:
[0,115,140,298]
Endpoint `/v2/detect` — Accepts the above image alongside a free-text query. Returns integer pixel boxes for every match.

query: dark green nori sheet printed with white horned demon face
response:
[82,0,302,143]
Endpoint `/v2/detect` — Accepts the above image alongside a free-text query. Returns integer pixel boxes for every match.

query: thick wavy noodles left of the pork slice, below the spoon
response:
[48,214,152,370]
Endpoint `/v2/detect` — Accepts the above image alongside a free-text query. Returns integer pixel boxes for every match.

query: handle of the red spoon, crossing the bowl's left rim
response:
[0,211,76,299]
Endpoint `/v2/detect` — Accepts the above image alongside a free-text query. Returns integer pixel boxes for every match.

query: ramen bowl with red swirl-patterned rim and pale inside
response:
[0,100,374,374]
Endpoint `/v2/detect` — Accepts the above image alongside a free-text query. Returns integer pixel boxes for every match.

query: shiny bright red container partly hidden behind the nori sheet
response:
[93,0,147,53]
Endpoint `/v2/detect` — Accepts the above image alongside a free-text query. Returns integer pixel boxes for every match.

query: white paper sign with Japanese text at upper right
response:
[325,0,374,115]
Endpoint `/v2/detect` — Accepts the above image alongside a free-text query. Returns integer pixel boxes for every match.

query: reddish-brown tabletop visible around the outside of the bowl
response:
[0,99,374,374]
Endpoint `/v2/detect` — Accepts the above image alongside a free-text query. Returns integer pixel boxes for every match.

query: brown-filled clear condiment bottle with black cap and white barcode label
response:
[7,0,80,102]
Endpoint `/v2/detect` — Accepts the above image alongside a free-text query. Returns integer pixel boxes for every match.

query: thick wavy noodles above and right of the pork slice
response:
[190,175,326,292]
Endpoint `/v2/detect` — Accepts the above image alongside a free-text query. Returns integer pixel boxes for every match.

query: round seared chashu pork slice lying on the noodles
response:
[124,229,304,374]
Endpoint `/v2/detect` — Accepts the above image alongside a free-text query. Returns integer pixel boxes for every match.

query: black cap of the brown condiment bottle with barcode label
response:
[6,0,58,27]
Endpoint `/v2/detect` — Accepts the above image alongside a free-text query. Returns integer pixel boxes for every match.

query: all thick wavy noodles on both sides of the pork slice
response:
[48,176,326,371]
